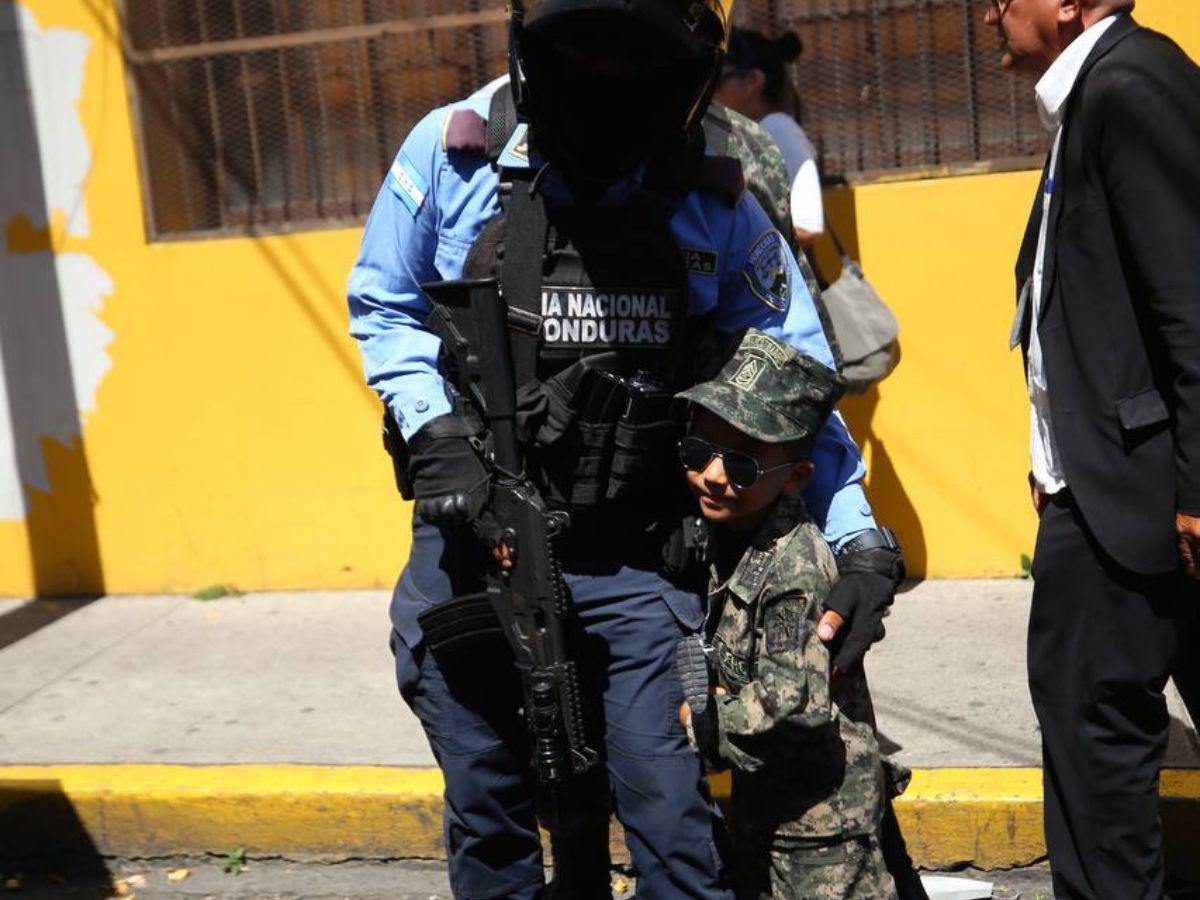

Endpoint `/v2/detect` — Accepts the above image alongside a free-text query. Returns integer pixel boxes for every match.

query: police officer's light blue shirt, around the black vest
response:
[348,78,875,550]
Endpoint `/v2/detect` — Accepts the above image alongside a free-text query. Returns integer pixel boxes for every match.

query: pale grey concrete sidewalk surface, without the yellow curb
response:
[0,581,1200,768]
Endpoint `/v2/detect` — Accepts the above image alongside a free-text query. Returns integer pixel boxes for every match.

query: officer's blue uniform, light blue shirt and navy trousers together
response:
[348,79,875,899]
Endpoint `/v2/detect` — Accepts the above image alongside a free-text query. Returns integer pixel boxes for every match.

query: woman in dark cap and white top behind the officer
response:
[715,28,824,247]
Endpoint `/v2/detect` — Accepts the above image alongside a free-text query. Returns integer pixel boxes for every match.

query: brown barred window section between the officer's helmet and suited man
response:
[738,0,1048,180]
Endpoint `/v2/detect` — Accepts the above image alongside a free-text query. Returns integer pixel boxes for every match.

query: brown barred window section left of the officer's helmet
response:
[121,0,506,238]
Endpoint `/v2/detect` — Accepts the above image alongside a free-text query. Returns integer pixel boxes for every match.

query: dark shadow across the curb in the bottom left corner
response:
[0,780,114,900]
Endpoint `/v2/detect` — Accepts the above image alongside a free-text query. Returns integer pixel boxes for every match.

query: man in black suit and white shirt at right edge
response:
[986,0,1200,900]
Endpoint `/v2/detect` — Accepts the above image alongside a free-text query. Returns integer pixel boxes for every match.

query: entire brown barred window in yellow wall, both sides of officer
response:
[121,0,1045,239]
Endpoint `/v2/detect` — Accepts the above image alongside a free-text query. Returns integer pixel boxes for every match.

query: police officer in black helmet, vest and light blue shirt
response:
[349,0,898,898]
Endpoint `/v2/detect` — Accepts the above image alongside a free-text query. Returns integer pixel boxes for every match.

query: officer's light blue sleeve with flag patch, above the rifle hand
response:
[347,110,450,439]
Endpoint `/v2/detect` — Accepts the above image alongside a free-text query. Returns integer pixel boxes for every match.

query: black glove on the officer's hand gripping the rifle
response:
[408,414,500,547]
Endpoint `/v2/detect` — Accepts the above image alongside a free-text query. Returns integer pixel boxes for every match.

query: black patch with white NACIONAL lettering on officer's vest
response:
[541,286,678,348]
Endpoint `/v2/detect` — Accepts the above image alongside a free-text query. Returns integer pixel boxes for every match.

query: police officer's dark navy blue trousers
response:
[392,521,732,900]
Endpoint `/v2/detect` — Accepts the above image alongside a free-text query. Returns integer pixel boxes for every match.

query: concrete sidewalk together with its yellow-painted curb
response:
[0,581,1200,868]
